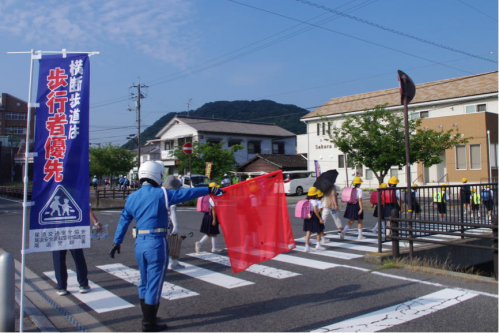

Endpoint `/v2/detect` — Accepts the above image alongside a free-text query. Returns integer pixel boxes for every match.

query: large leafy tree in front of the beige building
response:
[324,104,469,184]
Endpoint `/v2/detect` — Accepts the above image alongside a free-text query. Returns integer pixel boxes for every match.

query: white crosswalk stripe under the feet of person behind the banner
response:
[43,269,134,313]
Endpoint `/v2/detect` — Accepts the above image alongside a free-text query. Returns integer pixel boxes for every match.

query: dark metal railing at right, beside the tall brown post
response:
[378,183,498,280]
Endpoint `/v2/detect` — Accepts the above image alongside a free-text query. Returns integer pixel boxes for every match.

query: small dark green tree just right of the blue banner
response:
[89,144,135,178]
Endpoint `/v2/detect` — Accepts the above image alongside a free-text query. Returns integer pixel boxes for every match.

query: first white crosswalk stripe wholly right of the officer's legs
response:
[172,261,254,289]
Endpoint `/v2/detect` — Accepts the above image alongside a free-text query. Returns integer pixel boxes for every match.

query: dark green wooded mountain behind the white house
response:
[123,100,309,149]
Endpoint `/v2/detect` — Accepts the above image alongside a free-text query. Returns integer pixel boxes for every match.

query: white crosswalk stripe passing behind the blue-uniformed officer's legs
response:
[97,264,199,301]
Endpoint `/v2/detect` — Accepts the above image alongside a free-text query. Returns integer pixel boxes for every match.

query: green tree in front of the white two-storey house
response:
[173,142,244,179]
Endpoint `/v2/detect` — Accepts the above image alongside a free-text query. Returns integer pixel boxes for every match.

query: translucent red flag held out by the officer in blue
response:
[212,170,296,273]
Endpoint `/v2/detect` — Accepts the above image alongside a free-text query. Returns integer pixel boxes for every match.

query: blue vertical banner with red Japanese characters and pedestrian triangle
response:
[28,54,90,252]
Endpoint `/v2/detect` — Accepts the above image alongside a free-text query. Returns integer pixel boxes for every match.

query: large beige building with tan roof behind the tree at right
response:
[297,72,498,188]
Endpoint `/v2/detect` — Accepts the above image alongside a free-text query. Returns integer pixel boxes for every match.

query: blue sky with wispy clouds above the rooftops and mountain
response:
[0,0,498,145]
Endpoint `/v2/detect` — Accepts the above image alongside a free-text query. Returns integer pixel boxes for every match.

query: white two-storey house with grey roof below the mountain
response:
[152,116,296,174]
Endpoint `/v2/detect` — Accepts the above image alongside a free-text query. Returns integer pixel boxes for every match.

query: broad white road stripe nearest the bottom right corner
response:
[313,289,478,332]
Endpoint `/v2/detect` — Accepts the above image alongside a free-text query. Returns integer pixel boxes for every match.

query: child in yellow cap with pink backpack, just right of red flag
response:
[303,187,325,252]
